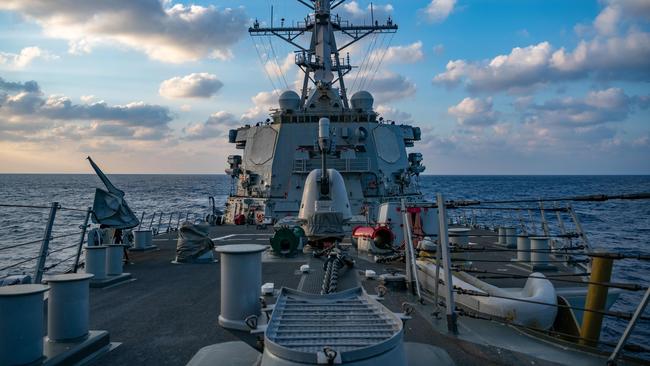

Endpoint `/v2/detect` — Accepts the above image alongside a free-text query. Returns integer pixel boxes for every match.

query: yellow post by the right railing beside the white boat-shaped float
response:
[580,254,614,346]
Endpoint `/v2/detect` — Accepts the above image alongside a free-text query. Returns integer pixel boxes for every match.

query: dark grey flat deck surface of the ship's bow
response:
[90,226,612,365]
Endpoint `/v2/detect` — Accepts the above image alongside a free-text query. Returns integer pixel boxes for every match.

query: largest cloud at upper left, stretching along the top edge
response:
[0,0,248,63]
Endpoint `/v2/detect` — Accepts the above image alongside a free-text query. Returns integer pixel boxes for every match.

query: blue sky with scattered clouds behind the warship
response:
[0,0,650,174]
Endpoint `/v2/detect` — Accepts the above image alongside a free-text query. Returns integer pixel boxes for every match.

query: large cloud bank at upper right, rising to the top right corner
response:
[433,0,650,92]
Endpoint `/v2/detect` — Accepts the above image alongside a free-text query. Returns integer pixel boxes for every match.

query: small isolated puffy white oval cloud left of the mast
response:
[158,72,223,99]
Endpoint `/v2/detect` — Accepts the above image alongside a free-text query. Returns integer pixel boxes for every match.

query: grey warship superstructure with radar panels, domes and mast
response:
[225,1,424,223]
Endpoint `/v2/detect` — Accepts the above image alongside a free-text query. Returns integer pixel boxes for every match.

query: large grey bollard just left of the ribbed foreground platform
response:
[216,244,266,330]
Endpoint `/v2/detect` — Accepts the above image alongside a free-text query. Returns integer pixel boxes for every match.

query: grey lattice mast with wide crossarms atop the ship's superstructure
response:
[248,0,397,109]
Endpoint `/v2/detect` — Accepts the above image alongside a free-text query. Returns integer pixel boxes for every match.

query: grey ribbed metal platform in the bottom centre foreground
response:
[262,287,406,366]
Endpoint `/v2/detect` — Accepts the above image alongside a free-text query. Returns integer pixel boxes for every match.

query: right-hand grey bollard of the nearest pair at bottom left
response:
[46,273,93,342]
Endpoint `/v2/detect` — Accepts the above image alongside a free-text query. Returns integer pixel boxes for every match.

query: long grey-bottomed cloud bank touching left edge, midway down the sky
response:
[0,79,173,140]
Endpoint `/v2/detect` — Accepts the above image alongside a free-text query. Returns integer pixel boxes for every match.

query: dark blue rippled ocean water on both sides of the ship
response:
[0,174,650,357]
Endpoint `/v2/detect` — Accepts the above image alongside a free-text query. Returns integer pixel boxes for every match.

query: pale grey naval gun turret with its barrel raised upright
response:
[298,118,352,246]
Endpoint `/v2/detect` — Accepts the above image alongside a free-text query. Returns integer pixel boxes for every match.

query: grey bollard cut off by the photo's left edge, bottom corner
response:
[0,285,49,366]
